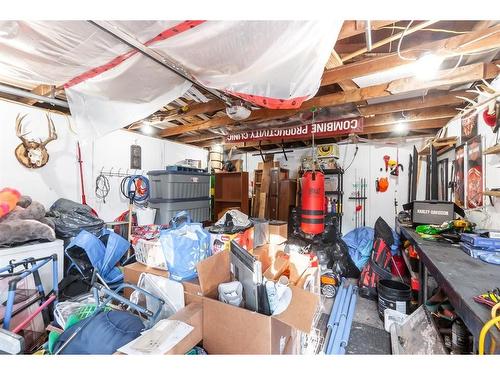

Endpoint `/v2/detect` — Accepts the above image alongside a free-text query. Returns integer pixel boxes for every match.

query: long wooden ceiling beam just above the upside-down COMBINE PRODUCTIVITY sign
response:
[161,62,499,137]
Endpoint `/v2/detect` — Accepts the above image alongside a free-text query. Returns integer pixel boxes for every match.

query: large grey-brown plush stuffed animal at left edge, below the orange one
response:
[0,192,56,251]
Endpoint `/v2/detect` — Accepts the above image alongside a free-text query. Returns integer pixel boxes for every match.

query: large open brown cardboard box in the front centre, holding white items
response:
[197,251,319,354]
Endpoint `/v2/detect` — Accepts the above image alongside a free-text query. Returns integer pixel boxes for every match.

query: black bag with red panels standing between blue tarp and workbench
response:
[358,217,394,300]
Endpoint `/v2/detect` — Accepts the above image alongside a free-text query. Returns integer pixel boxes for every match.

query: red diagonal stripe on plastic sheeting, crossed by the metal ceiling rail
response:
[64,21,205,89]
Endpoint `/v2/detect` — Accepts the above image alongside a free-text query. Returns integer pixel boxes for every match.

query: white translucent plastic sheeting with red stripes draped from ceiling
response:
[0,21,342,137]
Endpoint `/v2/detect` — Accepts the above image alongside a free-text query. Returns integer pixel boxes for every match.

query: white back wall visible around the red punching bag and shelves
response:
[233,141,425,234]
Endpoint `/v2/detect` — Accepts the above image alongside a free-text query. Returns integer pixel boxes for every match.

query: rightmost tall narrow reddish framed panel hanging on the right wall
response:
[467,135,484,208]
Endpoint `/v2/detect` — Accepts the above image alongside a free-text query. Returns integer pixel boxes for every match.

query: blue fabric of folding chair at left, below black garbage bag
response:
[66,229,130,284]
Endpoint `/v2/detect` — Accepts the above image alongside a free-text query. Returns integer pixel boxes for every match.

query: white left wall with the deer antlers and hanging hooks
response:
[0,100,208,221]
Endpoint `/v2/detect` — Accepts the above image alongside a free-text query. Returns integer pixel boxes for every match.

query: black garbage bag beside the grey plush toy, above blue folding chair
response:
[47,198,104,238]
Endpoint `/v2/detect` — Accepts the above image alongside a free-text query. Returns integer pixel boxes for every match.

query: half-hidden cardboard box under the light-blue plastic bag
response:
[123,262,202,306]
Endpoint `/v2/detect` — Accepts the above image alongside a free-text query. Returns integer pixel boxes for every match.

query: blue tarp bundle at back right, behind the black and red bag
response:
[342,227,400,270]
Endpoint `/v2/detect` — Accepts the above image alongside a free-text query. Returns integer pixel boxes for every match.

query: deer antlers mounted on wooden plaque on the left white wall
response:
[15,113,57,168]
